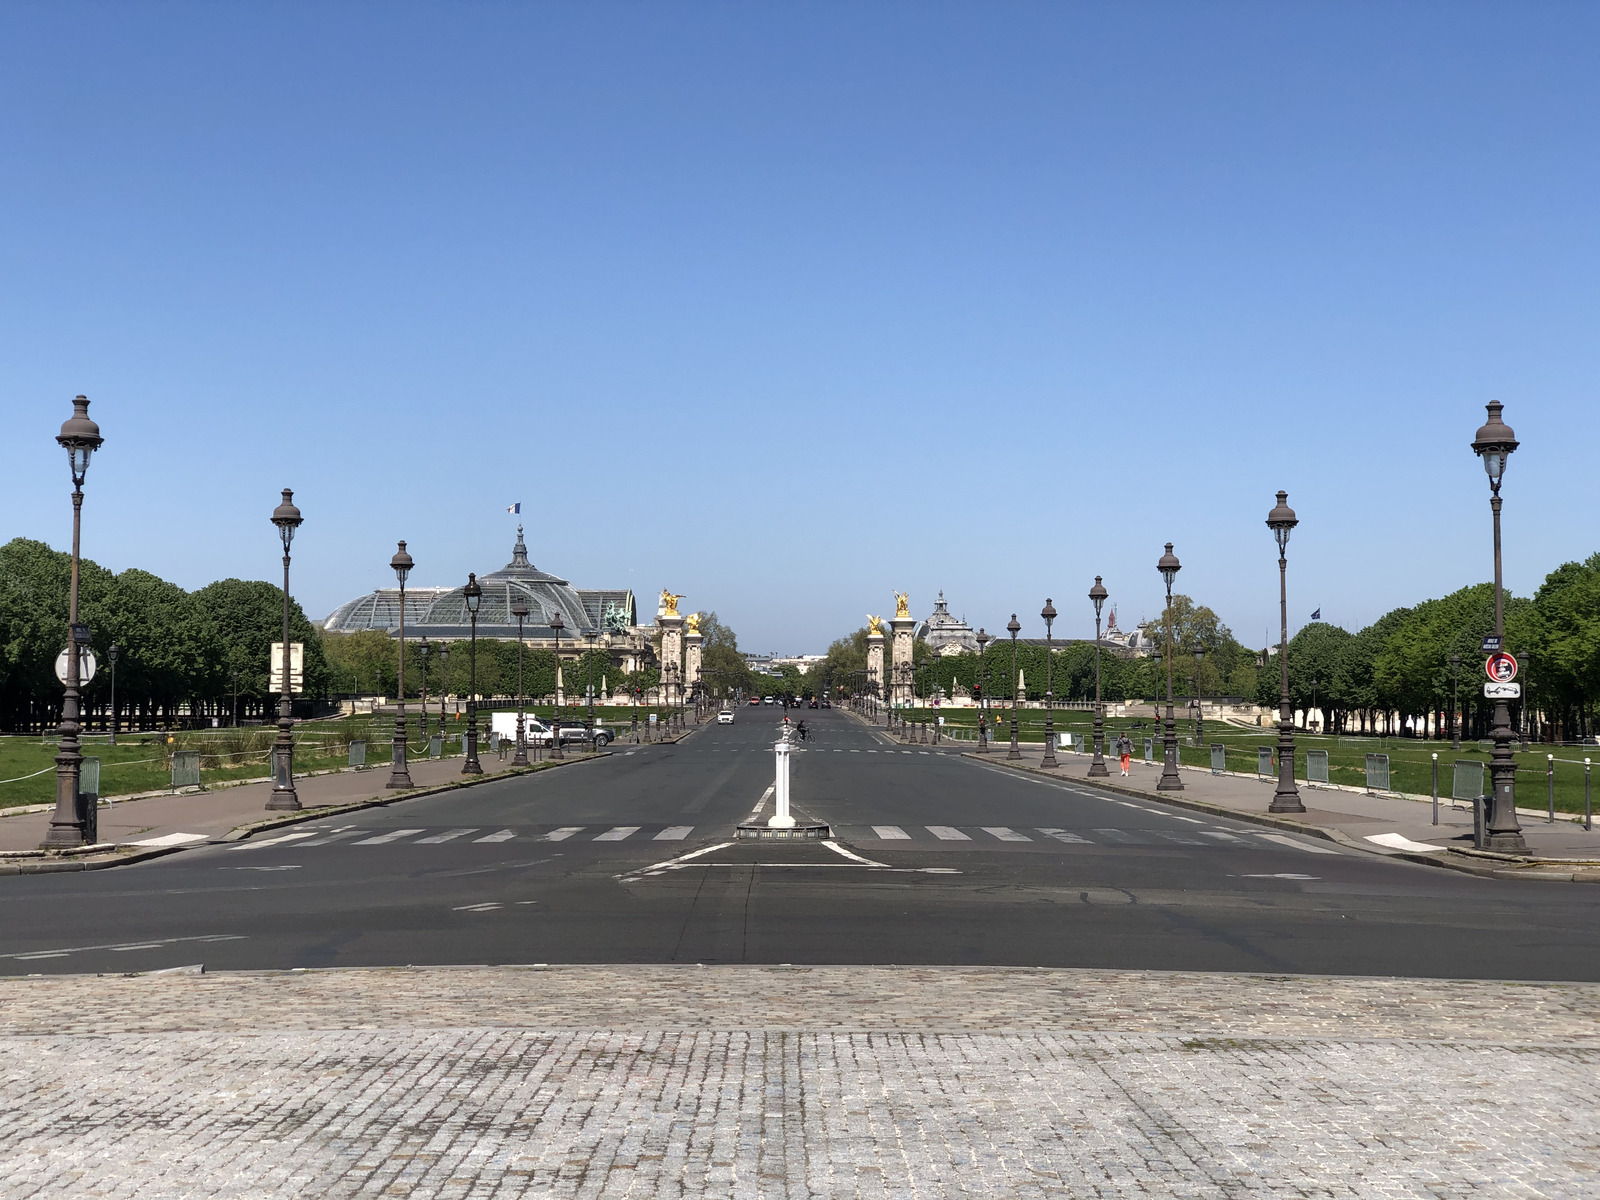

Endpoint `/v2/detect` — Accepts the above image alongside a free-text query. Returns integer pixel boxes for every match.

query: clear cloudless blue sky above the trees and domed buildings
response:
[0,2,1600,653]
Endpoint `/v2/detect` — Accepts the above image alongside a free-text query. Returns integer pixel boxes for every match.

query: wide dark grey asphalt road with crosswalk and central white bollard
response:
[0,709,1600,981]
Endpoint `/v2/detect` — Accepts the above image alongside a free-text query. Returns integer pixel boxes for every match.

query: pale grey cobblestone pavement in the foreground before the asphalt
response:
[0,966,1600,1200]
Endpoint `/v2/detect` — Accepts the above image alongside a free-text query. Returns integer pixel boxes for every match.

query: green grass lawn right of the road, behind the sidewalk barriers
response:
[907,709,1600,813]
